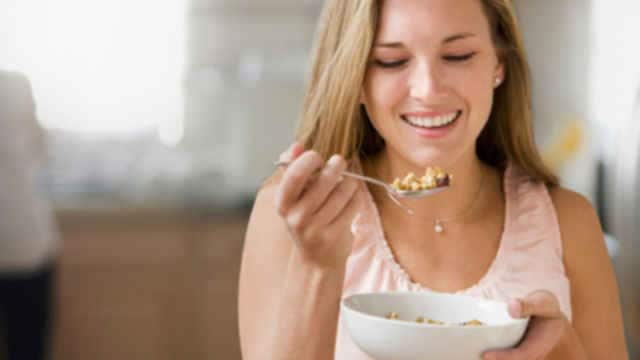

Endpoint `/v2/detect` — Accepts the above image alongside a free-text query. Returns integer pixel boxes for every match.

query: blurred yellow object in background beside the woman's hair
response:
[542,120,584,172]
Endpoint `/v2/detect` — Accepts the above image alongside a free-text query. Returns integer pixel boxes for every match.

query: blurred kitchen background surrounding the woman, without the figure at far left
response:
[0,0,640,359]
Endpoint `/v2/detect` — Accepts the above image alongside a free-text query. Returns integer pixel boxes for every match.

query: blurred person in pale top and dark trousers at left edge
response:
[0,71,58,360]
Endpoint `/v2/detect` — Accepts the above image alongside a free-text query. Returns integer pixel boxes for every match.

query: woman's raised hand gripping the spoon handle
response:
[275,144,362,268]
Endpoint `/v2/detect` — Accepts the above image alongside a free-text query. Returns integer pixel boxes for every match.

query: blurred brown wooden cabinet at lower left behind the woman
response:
[47,212,247,360]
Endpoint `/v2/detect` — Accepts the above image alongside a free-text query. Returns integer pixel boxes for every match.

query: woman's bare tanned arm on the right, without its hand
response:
[549,188,629,360]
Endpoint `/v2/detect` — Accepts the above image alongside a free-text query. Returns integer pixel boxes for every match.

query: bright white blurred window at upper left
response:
[0,0,187,144]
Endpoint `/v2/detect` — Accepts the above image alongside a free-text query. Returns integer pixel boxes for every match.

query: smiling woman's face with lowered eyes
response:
[361,0,503,167]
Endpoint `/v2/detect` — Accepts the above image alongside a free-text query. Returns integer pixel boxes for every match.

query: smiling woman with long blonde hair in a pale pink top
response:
[239,0,628,360]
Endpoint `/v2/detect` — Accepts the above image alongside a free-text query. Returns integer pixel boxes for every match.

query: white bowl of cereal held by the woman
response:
[340,292,529,360]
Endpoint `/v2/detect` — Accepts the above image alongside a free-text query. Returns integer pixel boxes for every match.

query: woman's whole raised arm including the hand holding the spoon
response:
[238,146,362,360]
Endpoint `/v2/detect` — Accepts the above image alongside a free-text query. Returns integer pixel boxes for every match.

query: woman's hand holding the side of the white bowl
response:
[482,290,569,360]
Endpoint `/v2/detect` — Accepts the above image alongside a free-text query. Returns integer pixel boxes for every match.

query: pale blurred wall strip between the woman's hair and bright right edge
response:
[507,0,599,202]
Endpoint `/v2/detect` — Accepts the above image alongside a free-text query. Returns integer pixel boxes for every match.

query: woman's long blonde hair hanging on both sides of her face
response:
[296,0,558,186]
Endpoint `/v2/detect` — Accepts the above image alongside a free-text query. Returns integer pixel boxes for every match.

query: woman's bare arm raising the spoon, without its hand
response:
[238,186,344,360]
